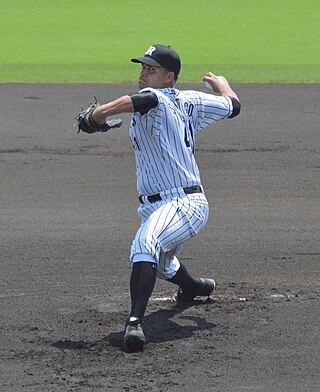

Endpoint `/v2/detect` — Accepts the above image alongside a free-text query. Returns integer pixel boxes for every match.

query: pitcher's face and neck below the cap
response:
[139,64,173,89]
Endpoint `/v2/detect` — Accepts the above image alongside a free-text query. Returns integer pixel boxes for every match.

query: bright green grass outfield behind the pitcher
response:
[0,0,320,83]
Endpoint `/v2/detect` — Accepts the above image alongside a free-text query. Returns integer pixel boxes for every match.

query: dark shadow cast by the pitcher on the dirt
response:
[105,301,217,349]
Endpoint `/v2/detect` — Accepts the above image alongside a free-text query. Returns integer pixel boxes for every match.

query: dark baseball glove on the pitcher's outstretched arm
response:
[76,97,122,133]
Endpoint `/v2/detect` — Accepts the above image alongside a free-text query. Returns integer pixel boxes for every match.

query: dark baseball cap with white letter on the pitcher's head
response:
[131,44,181,78]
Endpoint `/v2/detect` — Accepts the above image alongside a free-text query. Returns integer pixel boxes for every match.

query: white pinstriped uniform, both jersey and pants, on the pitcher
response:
[130,88,232,279]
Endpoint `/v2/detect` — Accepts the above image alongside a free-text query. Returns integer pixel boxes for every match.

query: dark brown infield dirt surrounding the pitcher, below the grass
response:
[0,84,320,392]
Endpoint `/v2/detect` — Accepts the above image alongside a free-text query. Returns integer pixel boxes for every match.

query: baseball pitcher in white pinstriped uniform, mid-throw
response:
[78,44,240,351]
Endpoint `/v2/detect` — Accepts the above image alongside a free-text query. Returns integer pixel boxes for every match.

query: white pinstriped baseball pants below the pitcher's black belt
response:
[130,192,209,279]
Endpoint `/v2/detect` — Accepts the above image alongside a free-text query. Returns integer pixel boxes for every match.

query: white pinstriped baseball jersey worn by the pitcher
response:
[130,88,233,195]
